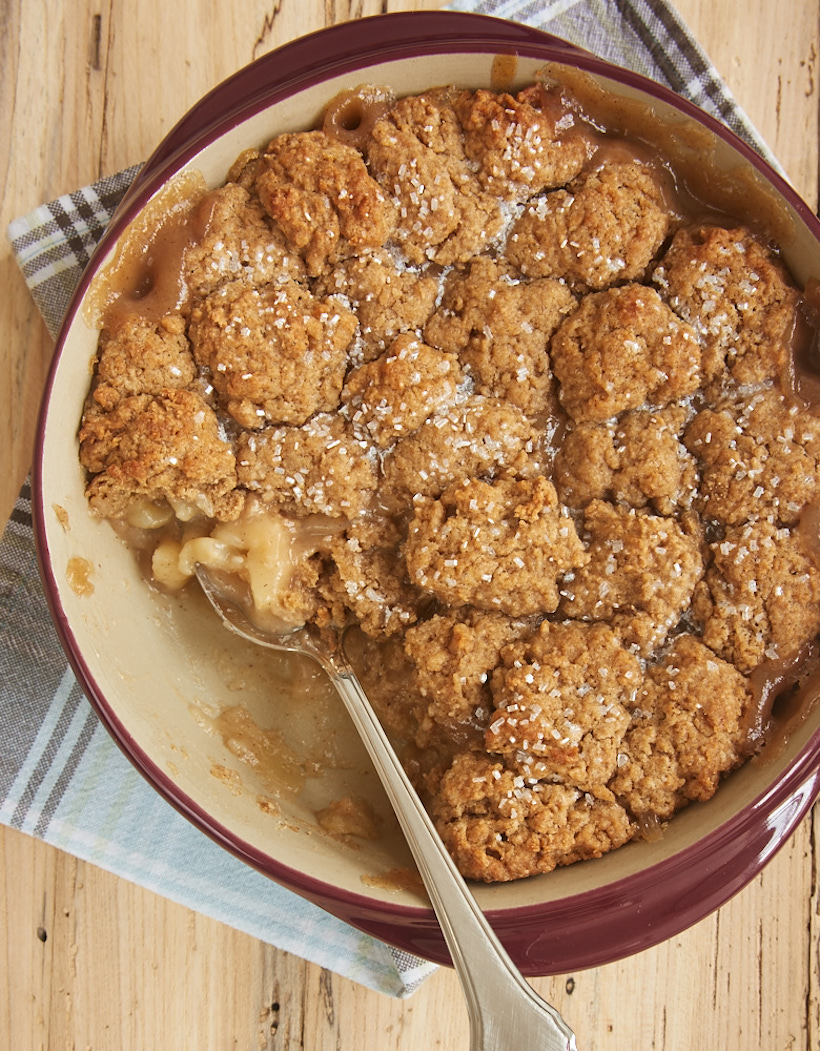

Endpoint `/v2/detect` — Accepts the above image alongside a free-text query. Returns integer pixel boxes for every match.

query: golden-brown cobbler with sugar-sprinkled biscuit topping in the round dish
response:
[80,69,820,882]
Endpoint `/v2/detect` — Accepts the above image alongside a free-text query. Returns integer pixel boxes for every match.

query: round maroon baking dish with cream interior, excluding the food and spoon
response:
[34,12,820,975]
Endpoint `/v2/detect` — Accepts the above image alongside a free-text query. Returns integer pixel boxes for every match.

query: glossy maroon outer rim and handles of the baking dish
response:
[33,12,820,975]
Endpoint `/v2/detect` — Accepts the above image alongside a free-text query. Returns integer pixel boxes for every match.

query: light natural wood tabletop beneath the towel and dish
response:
[0,0,820,1051]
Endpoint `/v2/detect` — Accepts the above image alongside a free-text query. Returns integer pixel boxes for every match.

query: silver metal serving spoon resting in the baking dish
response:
[197,565,577,1051]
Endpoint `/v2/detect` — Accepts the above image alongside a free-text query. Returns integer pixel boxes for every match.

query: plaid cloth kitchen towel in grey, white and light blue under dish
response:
[0,0,773,996]
